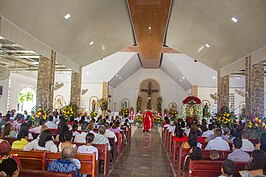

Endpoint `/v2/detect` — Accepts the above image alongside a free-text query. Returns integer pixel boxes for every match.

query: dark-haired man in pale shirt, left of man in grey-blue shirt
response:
[205,128,230,150]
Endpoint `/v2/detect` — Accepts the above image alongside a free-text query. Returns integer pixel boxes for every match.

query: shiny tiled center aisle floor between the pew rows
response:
[109,128,174,177]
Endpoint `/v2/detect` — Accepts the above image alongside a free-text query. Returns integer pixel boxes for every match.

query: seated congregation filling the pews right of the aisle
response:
[162,117,266,177]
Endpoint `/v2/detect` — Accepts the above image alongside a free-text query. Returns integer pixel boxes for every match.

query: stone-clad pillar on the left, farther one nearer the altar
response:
[70,67,82,107]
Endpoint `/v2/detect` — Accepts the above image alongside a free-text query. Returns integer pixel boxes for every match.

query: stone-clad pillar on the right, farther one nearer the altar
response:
[217,71,229,112]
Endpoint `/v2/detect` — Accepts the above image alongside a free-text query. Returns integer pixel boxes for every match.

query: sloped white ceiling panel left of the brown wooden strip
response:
[0,0,133,66]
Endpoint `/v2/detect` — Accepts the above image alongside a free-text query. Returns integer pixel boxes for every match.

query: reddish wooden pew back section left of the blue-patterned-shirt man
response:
[9,150,45,170]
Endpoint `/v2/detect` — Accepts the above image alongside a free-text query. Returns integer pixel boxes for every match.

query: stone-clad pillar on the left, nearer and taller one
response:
[36,50,56,111]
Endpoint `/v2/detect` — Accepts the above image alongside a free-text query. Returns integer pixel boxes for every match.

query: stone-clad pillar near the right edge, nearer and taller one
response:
[245,56,264,116]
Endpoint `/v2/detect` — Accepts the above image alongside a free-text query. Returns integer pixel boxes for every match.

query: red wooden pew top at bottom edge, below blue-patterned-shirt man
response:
[19,169,76,177]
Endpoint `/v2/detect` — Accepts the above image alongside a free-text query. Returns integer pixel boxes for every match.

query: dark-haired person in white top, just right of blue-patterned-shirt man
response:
[78,133,98,160]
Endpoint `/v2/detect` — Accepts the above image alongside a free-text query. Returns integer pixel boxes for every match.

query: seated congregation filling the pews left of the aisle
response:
[0,110,130,177]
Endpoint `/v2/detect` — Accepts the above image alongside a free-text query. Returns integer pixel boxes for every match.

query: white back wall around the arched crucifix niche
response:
[111,69,187,111]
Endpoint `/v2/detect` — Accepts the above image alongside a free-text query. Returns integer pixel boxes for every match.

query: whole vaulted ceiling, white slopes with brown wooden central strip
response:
[0,0,266,73]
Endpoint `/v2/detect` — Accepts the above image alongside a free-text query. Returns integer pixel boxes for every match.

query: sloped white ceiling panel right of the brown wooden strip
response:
[166,0,266,70]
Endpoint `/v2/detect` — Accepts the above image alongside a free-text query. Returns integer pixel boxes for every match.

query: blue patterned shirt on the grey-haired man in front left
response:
[48,159,80,177]
